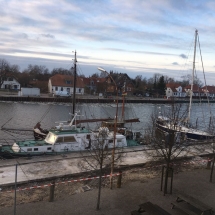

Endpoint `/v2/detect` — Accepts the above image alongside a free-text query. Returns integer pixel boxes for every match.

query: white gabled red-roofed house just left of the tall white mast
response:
[166,83,186,98]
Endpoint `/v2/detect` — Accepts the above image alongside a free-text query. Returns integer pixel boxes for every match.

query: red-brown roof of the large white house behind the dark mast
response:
[50,74,84,88]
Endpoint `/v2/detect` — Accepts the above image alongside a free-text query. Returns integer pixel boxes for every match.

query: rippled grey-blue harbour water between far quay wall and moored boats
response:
[0,102,215,143]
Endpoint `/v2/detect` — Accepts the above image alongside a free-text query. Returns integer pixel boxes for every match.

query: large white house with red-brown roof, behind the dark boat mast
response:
[48,74,85,95]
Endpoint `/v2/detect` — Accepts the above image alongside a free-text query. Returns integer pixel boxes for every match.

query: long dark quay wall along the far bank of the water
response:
[0,96,215,104]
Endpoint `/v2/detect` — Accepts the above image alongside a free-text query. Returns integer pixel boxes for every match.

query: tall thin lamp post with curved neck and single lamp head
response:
[98,67,118,189]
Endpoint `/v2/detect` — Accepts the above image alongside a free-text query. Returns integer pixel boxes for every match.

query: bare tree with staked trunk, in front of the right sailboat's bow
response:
[145,101,188,194]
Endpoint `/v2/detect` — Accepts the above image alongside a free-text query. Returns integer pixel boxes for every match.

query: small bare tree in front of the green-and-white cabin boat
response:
[80,127,123,210]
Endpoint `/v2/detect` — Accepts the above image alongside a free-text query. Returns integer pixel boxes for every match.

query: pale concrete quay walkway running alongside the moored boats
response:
[0,146,211,185]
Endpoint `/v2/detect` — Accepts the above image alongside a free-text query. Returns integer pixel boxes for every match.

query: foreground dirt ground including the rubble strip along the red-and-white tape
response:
[0,156,215,215]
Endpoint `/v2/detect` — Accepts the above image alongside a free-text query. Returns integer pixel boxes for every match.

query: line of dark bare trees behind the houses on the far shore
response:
[0,59,202,96]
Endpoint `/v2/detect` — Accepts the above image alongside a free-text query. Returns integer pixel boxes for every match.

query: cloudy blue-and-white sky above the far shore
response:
[0,0,215,84]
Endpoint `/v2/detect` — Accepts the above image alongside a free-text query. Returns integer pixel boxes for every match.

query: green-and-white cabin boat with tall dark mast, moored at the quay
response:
[0,52,141,158]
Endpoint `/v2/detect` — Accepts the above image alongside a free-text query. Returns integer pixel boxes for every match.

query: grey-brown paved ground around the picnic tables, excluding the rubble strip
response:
[0,169,215,215]
